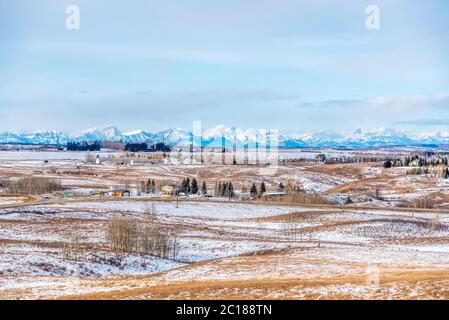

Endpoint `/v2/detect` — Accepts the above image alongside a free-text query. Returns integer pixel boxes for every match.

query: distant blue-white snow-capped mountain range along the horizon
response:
[0,125,449,149]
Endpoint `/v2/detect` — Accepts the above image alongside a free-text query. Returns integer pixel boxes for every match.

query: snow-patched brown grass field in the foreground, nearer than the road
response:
[0,200,449,298]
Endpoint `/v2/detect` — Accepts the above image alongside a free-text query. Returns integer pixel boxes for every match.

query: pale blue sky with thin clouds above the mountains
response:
[0,0,449,132]
